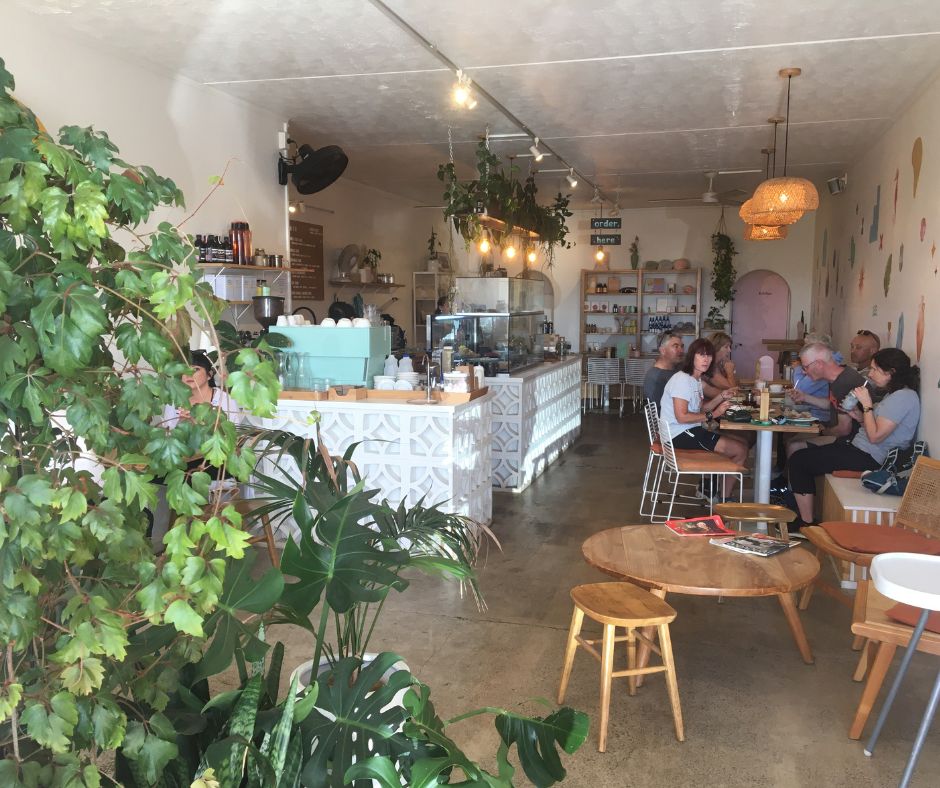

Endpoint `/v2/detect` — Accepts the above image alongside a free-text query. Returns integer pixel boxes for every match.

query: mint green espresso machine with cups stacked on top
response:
[270,326,392,388]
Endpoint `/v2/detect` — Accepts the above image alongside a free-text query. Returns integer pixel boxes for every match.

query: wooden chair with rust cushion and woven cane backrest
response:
[800,457,940,664]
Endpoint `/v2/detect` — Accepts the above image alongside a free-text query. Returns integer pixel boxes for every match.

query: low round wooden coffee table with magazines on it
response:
[581,525,819,664]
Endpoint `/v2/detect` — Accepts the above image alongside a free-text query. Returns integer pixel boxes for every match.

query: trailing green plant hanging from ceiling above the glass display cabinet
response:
[437,140,572,265]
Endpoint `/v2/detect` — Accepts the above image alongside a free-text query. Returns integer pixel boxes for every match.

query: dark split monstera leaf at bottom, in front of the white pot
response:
[300,653,414,788]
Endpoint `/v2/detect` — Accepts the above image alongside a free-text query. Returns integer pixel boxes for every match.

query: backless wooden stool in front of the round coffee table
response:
[558,583,685,752]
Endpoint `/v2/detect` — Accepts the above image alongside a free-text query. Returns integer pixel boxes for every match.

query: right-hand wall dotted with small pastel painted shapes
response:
[813,71,940,456]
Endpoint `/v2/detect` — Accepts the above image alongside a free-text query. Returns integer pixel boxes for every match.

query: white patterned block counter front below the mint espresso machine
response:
[253,394,493,524]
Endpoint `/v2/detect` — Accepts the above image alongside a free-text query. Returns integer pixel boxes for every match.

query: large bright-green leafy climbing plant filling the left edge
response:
[0,60,283,786]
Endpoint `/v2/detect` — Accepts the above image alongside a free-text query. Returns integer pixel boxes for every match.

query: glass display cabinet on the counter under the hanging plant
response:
[427,277,545,377]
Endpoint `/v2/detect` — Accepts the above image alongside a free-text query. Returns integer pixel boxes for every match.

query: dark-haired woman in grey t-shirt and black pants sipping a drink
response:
[789,348,920,527]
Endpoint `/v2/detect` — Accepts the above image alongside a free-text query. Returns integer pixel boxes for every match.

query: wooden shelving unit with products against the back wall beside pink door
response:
[581,268,702,356]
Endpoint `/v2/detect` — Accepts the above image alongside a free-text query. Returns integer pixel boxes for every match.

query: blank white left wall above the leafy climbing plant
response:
[0,4,286,298]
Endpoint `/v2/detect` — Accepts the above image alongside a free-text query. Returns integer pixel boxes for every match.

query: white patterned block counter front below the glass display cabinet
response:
[486,356,581,491]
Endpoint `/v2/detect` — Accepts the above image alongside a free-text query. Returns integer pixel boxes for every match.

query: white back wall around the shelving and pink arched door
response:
[448,206,814,348]
